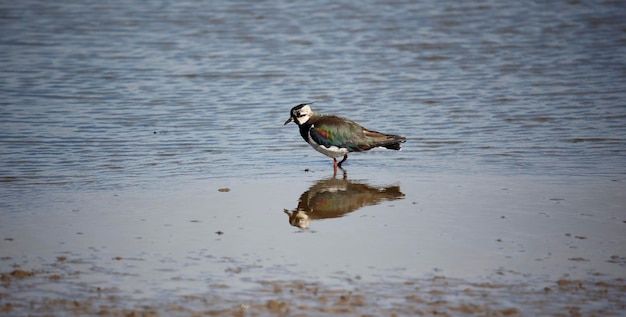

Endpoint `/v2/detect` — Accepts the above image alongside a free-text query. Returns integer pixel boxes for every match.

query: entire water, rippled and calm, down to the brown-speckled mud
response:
[0,1,626,313]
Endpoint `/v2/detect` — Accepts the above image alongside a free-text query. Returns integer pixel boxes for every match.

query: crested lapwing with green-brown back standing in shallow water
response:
[284,103,406,170]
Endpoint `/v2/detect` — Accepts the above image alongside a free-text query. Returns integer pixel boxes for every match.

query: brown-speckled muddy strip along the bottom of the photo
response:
[0,266,626,316]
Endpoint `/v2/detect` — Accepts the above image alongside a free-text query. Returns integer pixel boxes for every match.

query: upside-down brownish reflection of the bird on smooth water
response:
[284,171,404,229]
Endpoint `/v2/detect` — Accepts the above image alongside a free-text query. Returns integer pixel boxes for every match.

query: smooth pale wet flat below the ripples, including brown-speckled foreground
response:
[0,172,626,316]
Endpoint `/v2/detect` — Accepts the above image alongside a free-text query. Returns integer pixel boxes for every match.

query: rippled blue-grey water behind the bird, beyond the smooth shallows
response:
[0,1,626,188]
